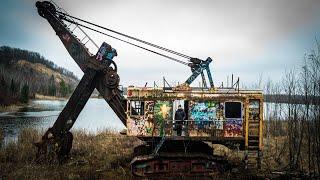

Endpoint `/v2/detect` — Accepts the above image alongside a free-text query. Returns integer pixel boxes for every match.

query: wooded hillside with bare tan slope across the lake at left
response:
[0,46,79,105]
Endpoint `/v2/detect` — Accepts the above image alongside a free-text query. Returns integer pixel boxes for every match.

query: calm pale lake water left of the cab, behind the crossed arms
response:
[0,98,124,141]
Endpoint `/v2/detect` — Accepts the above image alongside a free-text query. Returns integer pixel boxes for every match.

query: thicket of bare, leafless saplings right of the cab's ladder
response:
[265,41,320,177]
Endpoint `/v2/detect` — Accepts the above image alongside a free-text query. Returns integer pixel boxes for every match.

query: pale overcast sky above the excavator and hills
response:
[0,0,320,86]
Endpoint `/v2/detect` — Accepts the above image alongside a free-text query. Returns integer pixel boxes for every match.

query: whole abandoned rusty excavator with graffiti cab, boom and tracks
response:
[35,1,263,177]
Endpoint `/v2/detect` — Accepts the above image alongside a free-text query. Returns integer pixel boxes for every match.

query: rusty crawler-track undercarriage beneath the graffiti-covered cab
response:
[131,140,231,177]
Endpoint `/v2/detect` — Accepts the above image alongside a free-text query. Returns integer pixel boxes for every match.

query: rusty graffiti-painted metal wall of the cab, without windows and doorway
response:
[127,87,262,141]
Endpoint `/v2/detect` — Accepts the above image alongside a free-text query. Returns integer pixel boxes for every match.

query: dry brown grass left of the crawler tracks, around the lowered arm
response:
[0,129,141,179]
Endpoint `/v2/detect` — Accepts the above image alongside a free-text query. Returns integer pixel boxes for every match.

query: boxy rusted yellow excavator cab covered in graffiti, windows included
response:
[123,87,263,151]
